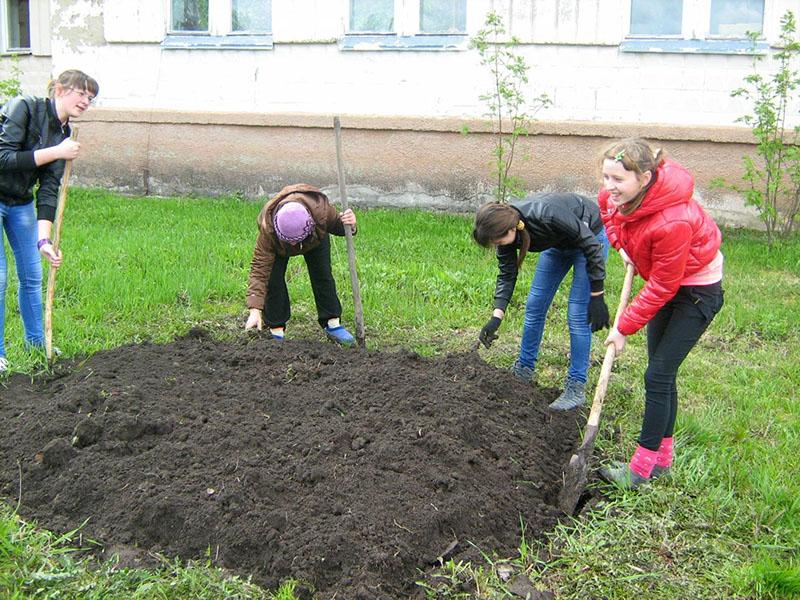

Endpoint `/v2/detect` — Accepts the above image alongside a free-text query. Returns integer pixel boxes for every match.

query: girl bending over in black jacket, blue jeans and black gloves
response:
[472,193,608,410]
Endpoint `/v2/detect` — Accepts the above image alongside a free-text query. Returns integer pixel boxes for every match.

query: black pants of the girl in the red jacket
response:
[639,283,723,450]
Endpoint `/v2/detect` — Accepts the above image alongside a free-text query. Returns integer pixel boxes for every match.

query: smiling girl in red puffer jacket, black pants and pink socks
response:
[598,138,723,488]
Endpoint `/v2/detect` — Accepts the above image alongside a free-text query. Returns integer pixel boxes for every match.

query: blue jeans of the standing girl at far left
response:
[0,202,44,356]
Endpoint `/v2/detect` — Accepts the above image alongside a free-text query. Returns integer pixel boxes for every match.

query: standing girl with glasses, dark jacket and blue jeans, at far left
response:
[0,71,99,373]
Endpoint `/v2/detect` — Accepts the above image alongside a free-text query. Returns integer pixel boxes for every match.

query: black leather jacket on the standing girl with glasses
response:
[0,96,70,221]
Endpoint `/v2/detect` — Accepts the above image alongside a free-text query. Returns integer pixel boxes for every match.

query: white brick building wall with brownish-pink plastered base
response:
[7,0,800,226]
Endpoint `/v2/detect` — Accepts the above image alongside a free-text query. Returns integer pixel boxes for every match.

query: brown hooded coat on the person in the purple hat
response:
[247,183,348,310]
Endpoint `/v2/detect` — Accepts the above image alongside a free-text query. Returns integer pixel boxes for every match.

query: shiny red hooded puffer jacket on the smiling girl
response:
[597,159,722,335]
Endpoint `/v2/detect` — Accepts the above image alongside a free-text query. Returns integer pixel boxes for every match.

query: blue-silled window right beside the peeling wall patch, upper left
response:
[162,0,272,50]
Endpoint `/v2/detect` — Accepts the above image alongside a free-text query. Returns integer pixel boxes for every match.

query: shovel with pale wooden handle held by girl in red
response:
[558,265,634,515]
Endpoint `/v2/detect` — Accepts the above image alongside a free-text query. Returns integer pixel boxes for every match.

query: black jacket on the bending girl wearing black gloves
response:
[494,193,606,310]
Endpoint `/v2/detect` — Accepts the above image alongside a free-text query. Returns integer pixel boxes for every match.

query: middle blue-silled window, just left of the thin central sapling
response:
[342,0,468,50]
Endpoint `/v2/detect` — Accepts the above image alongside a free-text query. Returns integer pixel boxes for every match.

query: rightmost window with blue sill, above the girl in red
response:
[620,0,766,54]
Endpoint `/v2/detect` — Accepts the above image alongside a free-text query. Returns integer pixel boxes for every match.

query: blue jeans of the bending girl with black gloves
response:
[518,229,608,383]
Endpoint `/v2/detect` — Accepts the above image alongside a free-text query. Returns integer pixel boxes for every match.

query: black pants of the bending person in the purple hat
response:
[264,234,342,327]
